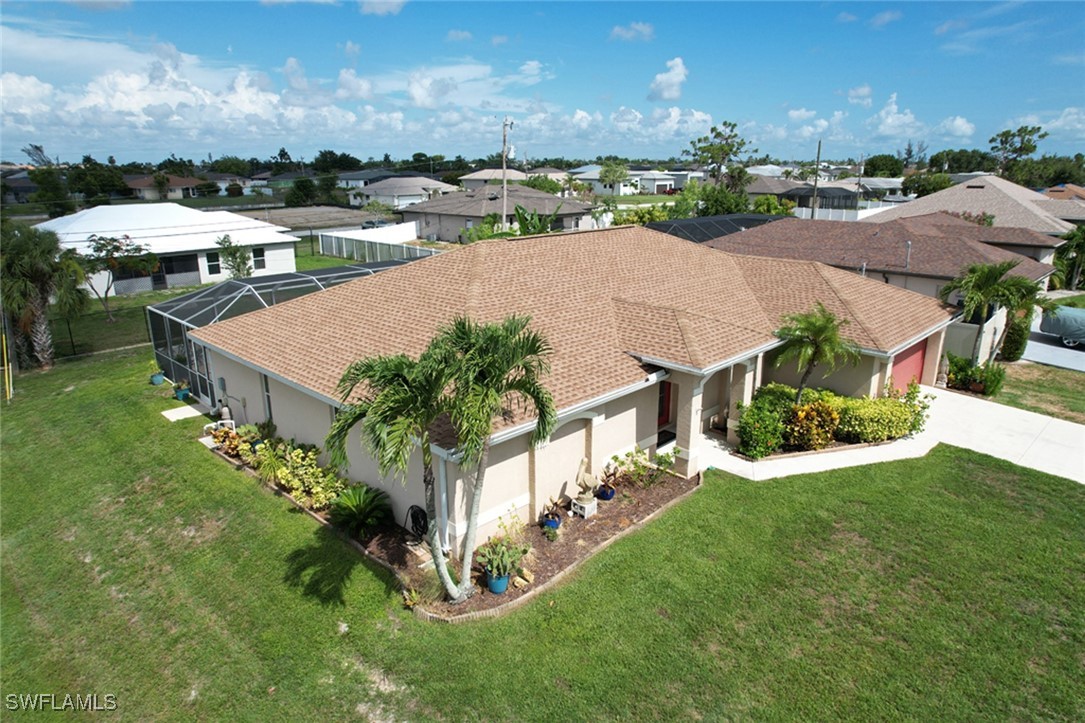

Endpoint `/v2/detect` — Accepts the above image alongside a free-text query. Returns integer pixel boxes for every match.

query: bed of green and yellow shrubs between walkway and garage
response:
[738,383,930,459]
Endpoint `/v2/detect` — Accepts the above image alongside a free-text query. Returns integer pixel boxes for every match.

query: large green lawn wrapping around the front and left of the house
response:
[0,353,1085,721]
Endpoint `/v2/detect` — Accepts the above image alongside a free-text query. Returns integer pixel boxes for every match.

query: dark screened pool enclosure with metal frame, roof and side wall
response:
[146,259,411,406]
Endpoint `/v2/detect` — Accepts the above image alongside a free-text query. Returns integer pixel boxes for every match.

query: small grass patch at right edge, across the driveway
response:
[993,362,1085,424]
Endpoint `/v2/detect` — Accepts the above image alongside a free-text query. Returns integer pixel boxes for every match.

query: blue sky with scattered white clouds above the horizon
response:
[0,0,1085,162]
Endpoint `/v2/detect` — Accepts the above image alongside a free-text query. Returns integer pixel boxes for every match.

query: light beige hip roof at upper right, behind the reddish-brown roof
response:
[859,175,1074,236]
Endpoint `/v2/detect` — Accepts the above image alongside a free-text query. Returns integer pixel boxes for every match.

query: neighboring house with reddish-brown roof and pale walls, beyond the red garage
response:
[703,214,1055,358]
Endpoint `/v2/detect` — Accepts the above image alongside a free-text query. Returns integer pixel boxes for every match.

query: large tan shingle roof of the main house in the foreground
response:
[192,227,953,423]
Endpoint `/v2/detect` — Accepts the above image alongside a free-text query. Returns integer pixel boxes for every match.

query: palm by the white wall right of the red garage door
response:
[939,261,1046,364]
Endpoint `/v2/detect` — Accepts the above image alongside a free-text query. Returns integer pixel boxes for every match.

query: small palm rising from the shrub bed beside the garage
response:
[775,302,859,404]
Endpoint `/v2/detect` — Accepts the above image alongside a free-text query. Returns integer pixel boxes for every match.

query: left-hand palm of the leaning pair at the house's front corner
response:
[324,344,459,598]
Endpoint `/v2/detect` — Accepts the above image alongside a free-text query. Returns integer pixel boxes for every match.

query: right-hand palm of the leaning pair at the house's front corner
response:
[434,316,557,601]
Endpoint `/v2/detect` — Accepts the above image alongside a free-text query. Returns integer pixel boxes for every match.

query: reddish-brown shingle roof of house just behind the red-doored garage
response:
[703,213,1055,280]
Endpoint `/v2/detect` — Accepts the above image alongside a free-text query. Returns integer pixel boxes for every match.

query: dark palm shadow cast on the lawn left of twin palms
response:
[282,525,397,607]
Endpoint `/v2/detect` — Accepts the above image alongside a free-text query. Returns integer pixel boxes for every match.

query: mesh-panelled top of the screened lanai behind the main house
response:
[148,259,412,329]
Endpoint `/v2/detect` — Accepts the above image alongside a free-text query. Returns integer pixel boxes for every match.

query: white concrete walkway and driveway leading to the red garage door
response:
[701,386,1085,483]
